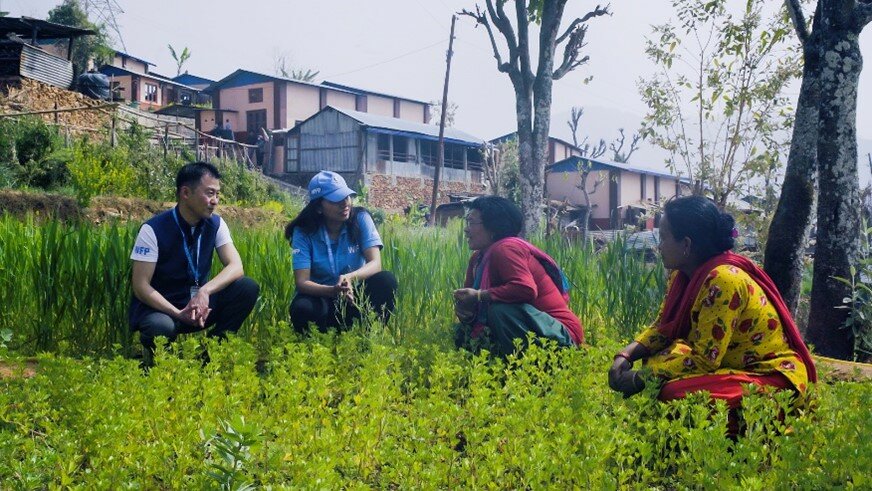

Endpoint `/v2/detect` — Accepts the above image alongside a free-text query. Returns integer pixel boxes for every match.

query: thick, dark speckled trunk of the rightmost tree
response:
[807,31,863,359]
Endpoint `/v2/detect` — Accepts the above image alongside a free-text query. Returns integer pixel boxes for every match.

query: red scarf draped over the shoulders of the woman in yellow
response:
[657,251,817,382]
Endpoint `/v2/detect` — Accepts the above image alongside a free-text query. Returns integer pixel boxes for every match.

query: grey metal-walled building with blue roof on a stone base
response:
[273,106,486,210]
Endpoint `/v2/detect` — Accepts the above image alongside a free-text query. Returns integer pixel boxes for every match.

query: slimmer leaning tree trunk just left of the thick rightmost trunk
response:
[763,39,820,314]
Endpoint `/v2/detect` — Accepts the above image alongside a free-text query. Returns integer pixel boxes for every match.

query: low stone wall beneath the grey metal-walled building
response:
[366,174,486,212]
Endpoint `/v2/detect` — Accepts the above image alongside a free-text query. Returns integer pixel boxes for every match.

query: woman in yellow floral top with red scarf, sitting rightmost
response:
[609,196,817,416]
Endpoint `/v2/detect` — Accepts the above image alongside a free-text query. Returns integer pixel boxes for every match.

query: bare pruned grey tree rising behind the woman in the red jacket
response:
[460,0,609,233]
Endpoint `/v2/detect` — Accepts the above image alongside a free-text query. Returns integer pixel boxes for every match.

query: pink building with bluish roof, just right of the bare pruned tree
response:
[545,156,690,230]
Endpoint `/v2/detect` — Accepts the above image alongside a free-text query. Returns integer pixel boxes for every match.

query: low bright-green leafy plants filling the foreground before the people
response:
[0,338,872,490]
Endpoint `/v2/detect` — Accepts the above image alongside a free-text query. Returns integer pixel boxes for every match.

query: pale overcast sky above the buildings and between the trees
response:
[6,0,872,174]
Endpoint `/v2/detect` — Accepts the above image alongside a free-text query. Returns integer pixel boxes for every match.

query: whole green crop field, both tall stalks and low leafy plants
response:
[0,218,872,489]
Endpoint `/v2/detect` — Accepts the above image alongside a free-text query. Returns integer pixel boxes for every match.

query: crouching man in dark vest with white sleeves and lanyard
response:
[130,162,259,360]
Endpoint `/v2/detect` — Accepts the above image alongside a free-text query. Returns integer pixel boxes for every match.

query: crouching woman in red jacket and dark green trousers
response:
[454,196,584,356]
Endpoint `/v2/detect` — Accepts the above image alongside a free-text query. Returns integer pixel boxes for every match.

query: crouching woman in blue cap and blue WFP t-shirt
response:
[285,171,397,334]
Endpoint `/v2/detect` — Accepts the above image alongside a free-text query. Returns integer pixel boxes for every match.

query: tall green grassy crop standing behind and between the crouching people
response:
[0,213,664,355]
